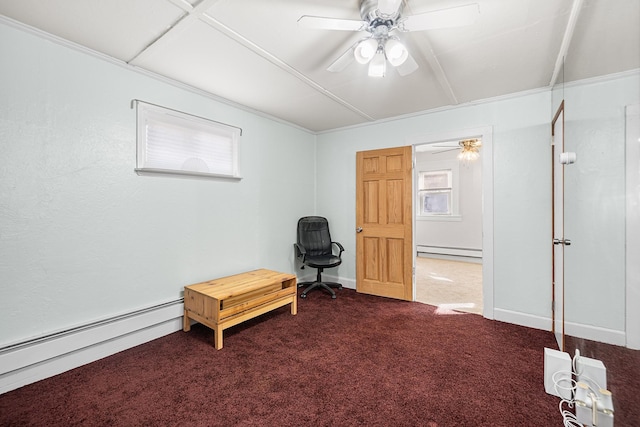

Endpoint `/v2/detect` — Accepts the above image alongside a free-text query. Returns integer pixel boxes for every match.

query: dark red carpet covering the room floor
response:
[0,289,640,427]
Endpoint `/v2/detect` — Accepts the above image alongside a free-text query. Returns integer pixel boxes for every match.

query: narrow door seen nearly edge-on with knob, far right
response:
[551,101,566,351]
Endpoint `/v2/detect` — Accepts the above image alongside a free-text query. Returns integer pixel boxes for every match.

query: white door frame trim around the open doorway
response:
[406,126,494,319]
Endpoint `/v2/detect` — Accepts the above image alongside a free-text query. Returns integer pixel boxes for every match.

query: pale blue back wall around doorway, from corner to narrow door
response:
[317,93,551,316]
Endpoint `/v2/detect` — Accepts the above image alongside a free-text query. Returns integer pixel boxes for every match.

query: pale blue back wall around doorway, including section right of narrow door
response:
[317,73,640,342]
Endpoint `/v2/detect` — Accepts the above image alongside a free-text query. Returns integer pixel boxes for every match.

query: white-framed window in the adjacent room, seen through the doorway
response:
[418,169,453,216]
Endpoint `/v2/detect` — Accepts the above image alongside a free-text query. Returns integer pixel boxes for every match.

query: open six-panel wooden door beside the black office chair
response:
[356,147,413,301]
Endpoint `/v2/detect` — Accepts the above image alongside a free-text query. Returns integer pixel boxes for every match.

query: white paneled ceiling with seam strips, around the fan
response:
[0,0,640,132]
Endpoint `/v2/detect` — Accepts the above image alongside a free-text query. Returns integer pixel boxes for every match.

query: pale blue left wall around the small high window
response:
[0,25,315,347]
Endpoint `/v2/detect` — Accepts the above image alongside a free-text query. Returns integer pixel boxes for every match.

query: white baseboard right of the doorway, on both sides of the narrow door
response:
[494,308,626,347]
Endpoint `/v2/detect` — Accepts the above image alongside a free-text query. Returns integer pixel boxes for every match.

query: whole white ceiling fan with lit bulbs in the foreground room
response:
[298,0,479,77]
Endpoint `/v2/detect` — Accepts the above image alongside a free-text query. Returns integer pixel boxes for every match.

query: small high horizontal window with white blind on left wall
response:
[136,101,241,179]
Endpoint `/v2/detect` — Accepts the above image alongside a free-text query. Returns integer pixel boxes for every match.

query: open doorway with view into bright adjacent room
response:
[412,127,493,319]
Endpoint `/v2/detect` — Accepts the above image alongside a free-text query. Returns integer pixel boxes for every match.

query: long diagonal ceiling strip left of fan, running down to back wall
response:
[200,13,376,121]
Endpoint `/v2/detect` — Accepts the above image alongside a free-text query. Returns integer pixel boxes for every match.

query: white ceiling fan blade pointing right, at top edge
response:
[400,3,480,31]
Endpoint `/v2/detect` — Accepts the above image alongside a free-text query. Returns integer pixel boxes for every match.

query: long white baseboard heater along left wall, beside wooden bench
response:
[0,300,184,394]
